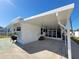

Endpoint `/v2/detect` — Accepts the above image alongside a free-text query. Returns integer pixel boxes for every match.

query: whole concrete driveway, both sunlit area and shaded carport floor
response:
[0,38,67,59]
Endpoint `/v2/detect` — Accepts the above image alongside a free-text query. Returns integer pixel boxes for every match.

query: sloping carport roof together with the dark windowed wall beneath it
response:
[24,4,74,40]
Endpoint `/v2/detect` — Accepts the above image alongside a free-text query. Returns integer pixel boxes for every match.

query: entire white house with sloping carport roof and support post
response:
[7,4,74,57]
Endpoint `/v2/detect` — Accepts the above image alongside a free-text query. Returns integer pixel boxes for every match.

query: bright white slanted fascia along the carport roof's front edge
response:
[24,3,75,21]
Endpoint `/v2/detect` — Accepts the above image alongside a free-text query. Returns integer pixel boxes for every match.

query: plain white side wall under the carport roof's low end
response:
[19,23,40,44]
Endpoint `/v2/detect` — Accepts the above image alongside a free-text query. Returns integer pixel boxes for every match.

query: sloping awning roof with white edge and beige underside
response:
[24,3,74,28]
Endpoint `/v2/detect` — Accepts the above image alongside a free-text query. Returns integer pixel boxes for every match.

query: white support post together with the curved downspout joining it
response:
[56,12,72,59]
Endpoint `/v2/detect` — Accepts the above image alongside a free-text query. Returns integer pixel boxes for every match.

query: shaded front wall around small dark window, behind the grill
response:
[6,23,22,41]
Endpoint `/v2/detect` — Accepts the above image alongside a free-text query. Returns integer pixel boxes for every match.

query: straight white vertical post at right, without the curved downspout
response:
[67,20,72,59]
